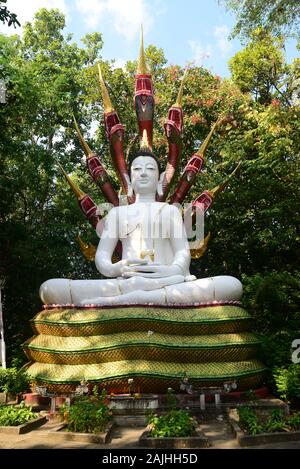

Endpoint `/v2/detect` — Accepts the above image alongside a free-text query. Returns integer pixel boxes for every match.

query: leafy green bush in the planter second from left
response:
[59,391,111,433]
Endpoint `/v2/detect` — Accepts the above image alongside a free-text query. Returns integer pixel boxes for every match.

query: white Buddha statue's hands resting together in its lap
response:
[122,263,182,278]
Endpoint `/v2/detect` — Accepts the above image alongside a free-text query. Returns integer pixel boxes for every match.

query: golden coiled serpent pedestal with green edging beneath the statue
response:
[23,303,266,394]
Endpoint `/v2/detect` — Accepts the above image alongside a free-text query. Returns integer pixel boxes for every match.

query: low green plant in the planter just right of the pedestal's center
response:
[147,410,197,438]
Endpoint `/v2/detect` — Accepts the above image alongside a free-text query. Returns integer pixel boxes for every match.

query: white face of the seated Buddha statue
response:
[130,156,159,194]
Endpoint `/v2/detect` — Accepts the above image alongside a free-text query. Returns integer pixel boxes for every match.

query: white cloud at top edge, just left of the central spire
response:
[76,0,153,41]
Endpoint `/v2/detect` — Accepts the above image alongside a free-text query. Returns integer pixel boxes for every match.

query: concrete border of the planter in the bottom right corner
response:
[229,410,300,447]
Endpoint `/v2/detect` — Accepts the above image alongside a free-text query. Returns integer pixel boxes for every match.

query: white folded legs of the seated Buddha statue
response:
[40,275,242,305]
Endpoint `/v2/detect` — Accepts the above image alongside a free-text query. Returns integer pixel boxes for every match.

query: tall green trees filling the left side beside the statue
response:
[0,9,102,362]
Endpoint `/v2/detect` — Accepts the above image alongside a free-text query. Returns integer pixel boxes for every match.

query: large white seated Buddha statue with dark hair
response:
[40,150,242,306]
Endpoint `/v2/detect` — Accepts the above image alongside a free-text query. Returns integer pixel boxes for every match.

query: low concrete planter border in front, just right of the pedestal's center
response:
[139,429,209,449]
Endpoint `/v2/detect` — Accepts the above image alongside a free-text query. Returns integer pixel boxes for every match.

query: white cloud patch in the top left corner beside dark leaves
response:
[0,0,67,35]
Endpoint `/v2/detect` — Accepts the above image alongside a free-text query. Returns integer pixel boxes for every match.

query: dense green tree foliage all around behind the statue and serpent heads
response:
[0,9,300,368]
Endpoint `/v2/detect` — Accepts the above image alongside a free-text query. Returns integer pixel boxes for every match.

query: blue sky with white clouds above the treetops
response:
[0,0,297,77]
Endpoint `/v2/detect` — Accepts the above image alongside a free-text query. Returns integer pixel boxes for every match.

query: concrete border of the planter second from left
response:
[45,422,114,444]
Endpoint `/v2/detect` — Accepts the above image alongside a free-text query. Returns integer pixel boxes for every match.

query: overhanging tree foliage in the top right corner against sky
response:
[220,0,300,38]
